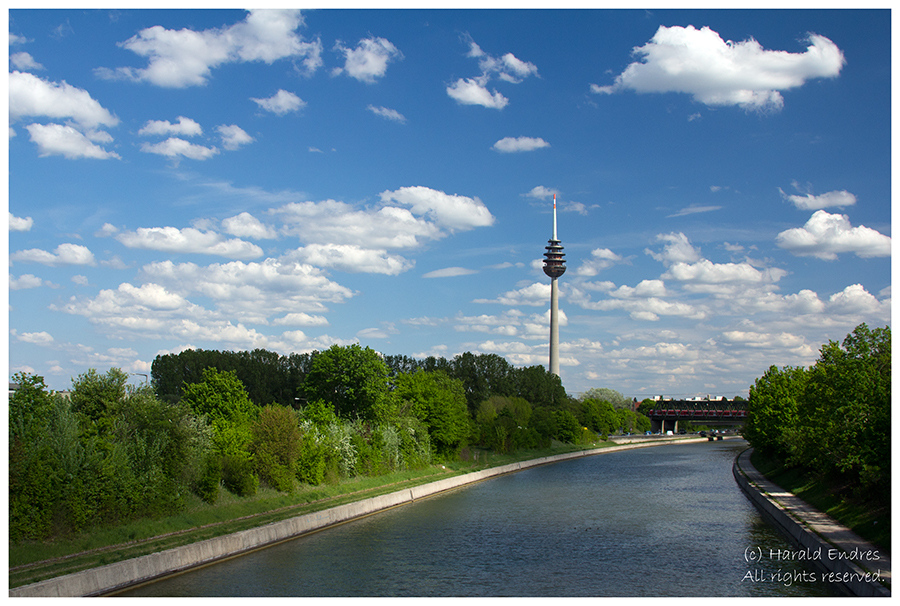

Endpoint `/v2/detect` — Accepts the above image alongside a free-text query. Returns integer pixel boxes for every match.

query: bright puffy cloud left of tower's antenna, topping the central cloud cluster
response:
[380,186,494,230]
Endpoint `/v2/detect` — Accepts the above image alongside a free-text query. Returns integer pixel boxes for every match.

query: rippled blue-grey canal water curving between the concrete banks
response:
[120,440,833,597]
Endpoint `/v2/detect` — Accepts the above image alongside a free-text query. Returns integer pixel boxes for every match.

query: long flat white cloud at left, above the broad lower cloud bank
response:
[116,227,263,259]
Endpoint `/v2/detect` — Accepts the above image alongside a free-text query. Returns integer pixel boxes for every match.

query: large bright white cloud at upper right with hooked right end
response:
[591,25,844,111]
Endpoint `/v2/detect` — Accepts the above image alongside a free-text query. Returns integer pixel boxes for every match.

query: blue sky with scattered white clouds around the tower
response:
[8,9,891,399]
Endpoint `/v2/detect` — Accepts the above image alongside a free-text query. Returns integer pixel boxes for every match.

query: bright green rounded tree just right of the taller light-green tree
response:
[394,370,471,456]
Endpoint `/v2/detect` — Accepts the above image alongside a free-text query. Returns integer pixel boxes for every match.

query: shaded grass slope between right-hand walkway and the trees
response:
[750,450,891,552]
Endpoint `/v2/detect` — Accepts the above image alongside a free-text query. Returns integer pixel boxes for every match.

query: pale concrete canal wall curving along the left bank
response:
[9,438,706,597]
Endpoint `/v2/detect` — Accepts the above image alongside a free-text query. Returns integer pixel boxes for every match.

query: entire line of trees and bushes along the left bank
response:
[9,345,650,541]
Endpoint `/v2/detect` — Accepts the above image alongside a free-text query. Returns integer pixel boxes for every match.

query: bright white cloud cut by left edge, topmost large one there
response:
[9,71,119,129]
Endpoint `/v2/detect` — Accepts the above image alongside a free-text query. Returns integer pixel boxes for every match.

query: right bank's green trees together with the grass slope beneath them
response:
[744,324,891,549]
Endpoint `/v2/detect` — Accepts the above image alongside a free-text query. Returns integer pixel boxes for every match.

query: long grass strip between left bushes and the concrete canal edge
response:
[9,442,614,587]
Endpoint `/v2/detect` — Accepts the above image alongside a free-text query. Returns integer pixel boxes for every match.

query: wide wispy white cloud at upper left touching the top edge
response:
[95,9,322,88]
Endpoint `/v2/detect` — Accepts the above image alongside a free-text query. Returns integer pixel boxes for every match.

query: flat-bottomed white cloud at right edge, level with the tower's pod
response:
[775,210,891,261]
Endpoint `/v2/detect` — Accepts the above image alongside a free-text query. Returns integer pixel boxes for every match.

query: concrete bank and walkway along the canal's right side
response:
[732,448,891,597]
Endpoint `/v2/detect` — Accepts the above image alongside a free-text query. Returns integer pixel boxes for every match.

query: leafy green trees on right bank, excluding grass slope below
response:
[745,324,891,502]
